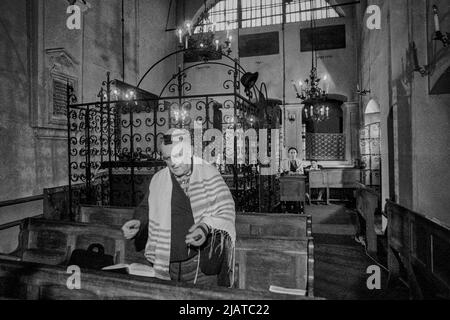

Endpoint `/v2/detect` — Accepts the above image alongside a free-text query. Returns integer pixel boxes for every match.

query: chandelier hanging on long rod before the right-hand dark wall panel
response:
[292,1,330,122]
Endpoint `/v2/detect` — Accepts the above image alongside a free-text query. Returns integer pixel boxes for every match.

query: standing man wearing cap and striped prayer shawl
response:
[122,129,236,286]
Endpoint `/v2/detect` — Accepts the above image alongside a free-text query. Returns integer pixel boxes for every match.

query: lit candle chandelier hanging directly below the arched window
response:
[176,1,232,55]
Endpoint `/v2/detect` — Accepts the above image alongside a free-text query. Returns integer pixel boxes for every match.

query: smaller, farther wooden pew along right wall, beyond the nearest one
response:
[355,184,380,256]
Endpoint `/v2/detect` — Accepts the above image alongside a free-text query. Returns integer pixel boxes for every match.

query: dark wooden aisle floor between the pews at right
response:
[305,204,409,300]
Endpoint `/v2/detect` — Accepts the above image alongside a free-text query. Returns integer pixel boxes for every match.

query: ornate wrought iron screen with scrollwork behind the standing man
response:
[67,52,270,218]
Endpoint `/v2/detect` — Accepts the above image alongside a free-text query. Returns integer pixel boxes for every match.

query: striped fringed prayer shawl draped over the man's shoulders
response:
[145,157,236,284]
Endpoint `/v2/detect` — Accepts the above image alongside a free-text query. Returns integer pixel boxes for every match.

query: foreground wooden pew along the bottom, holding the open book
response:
[0,259,317,300]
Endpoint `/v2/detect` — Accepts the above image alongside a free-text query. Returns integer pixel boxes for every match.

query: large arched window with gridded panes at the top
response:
[194,0,340,33]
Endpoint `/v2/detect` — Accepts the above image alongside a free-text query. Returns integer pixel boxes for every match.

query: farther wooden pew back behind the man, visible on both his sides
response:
[79,206,312,239]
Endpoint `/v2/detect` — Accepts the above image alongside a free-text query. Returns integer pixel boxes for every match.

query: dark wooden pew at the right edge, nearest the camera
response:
[385,200,450,299]
